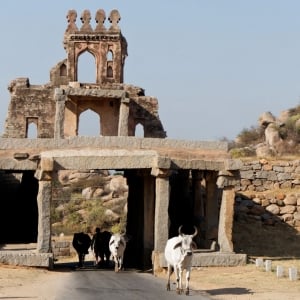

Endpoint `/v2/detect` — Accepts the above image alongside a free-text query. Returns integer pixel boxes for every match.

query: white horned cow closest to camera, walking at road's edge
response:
[165,226,198,295]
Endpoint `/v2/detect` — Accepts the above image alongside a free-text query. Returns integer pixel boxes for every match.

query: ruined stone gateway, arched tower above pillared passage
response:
[0,9,246,268]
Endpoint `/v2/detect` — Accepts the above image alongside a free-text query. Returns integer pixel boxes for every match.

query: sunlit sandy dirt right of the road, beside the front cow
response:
[155,259,300,300]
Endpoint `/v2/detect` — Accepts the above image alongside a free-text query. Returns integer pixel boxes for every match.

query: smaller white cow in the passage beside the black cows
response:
[109,233,128,272]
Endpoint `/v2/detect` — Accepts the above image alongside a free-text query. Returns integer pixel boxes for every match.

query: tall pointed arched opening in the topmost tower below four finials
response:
[77,51,96,83]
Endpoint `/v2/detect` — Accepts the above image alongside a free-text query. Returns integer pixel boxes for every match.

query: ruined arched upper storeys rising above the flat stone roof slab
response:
[3,9,166,139]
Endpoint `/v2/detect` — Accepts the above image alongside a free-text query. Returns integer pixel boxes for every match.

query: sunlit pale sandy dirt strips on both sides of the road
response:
[0,259,300,300]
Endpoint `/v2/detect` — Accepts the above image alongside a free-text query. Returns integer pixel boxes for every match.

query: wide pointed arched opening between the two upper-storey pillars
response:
[78,109,101,136]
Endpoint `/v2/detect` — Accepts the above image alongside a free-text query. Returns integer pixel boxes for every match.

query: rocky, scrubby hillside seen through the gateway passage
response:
[51,170,128,235]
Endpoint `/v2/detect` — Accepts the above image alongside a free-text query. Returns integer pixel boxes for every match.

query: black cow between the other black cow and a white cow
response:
[91,227,111,267]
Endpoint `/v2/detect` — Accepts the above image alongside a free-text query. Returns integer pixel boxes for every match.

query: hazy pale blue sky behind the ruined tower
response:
[0,0,300,140]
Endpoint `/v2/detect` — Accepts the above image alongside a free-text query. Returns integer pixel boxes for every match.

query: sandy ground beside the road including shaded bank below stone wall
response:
[0,207,300,300]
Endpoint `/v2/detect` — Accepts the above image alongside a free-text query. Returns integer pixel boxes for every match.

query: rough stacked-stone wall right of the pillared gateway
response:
[235,159,300,231]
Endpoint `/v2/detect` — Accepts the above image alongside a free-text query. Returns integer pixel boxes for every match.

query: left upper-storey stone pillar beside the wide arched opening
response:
[54,88,66,139]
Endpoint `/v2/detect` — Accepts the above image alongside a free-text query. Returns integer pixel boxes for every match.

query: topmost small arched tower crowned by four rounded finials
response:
[64,9,127,84]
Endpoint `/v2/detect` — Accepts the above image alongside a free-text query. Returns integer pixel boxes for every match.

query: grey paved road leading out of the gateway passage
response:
[55,267,211,300]
